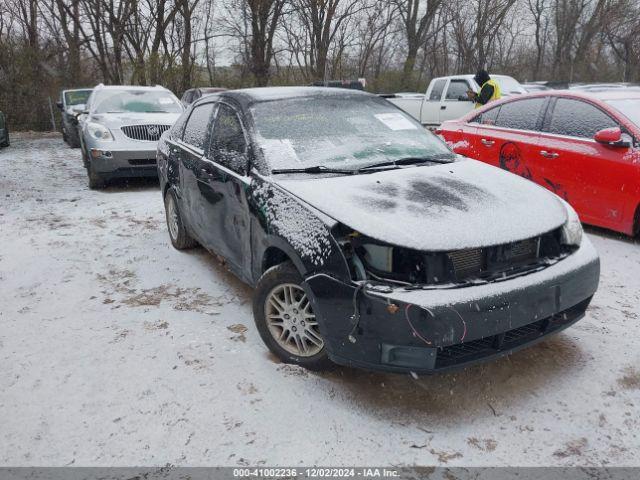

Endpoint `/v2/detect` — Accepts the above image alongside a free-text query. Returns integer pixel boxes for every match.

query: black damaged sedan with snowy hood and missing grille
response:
[158,87,600,373]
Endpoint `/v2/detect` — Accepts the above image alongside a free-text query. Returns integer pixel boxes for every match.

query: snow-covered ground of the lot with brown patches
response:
[0,136,640,466]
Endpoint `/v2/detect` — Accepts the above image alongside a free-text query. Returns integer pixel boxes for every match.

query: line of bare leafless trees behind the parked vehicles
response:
[0,0,640,129]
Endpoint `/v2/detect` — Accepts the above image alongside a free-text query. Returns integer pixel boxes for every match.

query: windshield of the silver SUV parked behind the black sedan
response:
[92,90,182,113]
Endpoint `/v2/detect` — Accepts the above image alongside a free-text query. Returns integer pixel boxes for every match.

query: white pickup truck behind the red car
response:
[383,75,527,128]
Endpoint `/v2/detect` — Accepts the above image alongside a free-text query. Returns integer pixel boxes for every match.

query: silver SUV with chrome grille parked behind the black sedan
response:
[80,84,183,188]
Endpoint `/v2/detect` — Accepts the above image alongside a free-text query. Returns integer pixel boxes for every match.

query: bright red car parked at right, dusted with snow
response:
[436,88,640,235]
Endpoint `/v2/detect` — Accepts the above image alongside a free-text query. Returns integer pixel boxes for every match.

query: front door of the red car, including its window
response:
[538,98,628,227]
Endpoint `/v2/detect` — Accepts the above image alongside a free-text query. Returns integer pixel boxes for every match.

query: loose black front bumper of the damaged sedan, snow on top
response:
[304,238,600,373]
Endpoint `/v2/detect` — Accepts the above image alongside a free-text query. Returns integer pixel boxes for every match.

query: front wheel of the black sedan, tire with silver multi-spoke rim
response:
[253,262,334,370]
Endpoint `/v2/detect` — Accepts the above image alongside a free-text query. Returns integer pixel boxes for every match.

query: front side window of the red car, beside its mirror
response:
[545,98,618,138]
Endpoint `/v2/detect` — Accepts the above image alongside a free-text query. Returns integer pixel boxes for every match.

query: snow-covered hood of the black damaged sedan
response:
[275,160,567,251]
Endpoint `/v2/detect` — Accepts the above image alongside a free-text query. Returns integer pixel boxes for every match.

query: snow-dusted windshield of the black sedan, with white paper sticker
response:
[251,95,452,169]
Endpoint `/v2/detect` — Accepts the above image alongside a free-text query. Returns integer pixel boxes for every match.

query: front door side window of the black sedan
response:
[209,104,247,175]
